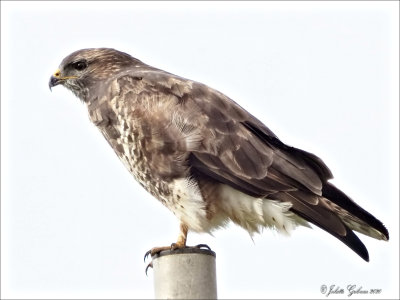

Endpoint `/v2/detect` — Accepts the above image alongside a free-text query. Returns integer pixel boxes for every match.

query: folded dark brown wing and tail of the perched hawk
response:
[106,70,388,260]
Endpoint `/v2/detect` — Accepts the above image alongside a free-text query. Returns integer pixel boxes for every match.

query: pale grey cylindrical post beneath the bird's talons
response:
[152,248,217,299]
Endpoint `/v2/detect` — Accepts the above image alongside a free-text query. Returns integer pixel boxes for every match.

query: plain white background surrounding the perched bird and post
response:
[1,1,399,299]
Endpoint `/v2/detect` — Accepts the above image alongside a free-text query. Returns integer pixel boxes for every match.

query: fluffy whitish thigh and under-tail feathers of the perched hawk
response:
[168,179,306,235]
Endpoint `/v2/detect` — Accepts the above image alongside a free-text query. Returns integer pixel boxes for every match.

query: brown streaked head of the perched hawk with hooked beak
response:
[49,48,139,101]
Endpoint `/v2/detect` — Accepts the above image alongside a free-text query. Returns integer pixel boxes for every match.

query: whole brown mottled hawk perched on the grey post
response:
[49,48,389,261]
